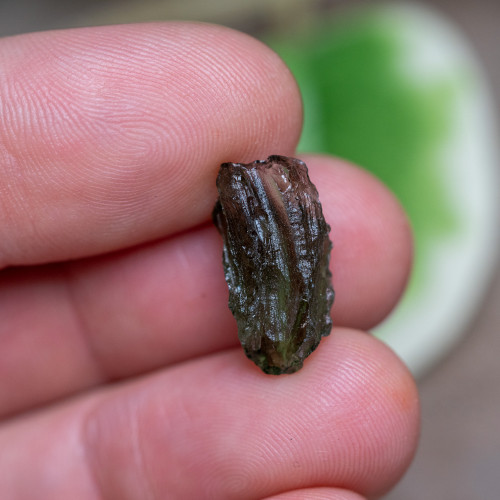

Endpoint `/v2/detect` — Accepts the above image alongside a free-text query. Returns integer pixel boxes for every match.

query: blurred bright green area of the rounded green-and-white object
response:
[271,10,458,288]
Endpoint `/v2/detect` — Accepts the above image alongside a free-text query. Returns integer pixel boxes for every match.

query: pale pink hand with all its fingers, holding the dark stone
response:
[0,23,419,500]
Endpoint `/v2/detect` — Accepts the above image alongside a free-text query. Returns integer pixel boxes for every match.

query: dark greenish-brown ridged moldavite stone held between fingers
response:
[213,156,334,375]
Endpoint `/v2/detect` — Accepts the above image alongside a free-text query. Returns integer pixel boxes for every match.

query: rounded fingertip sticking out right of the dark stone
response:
[306,157,413,330]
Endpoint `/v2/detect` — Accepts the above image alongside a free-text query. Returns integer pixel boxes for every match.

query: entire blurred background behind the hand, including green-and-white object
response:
[0,0,500,500]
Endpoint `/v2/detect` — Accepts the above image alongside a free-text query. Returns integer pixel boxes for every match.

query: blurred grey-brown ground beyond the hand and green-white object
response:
[0,0,500,500]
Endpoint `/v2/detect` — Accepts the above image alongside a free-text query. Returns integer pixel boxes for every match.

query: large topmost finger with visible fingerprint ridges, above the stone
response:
[0,23,301,267]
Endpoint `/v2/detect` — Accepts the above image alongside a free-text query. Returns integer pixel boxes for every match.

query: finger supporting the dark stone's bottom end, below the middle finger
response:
[0,330,418,500]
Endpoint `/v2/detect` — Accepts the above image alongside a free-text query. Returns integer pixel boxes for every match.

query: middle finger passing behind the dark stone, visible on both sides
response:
[0,157,411,415]
